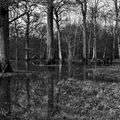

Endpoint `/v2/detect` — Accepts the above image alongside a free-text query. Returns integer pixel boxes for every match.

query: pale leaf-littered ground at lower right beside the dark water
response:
[55,65,120,120]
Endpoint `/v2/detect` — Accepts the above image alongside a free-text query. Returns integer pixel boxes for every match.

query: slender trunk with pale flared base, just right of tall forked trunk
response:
[92,16,97,60]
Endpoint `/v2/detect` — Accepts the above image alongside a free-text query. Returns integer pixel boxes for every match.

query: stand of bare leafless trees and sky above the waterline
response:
[0,0,120,71]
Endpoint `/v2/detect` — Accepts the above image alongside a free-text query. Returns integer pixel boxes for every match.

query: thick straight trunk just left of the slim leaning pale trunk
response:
[46,0,53,62]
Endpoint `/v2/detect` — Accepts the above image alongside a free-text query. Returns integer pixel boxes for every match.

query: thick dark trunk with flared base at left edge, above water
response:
[0,6,12,72]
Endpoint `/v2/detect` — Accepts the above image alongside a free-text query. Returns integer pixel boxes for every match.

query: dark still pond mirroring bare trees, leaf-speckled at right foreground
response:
[0,61,120,120]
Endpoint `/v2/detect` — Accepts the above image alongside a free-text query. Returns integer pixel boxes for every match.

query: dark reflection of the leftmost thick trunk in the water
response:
[0,77,11,120]
